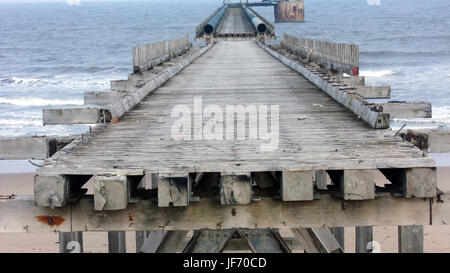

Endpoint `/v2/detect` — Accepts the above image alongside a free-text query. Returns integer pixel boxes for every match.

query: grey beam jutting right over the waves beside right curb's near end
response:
[379,101,432,118]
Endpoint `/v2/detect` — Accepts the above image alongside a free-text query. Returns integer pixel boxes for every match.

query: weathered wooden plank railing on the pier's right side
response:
[281,34,359,76]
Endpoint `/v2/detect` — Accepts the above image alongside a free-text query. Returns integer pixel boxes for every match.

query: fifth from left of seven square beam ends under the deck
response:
[281,171,314,201]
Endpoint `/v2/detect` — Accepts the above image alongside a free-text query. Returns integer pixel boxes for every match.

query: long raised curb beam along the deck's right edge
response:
[256,41,390,129]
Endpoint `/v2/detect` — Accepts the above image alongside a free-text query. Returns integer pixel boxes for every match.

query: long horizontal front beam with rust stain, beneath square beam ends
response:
[0,193,436,232]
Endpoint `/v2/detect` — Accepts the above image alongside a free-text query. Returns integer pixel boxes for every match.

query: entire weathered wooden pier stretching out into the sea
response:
[0,4,450,253]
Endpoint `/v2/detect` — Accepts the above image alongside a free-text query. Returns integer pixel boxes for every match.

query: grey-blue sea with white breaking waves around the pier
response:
[0,0,450,137]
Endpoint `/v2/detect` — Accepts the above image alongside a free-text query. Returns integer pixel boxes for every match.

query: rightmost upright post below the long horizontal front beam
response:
[398,225,423,253]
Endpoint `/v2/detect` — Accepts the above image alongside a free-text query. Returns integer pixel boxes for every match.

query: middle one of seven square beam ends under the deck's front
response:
[219,173,252,205]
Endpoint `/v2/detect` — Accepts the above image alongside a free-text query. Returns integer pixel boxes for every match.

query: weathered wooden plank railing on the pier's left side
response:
[133,35,190,73]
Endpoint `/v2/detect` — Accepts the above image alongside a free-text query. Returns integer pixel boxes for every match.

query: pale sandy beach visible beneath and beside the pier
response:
[0,167,450,253]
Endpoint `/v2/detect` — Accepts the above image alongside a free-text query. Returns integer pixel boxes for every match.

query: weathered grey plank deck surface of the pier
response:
[38,40,434,175]
